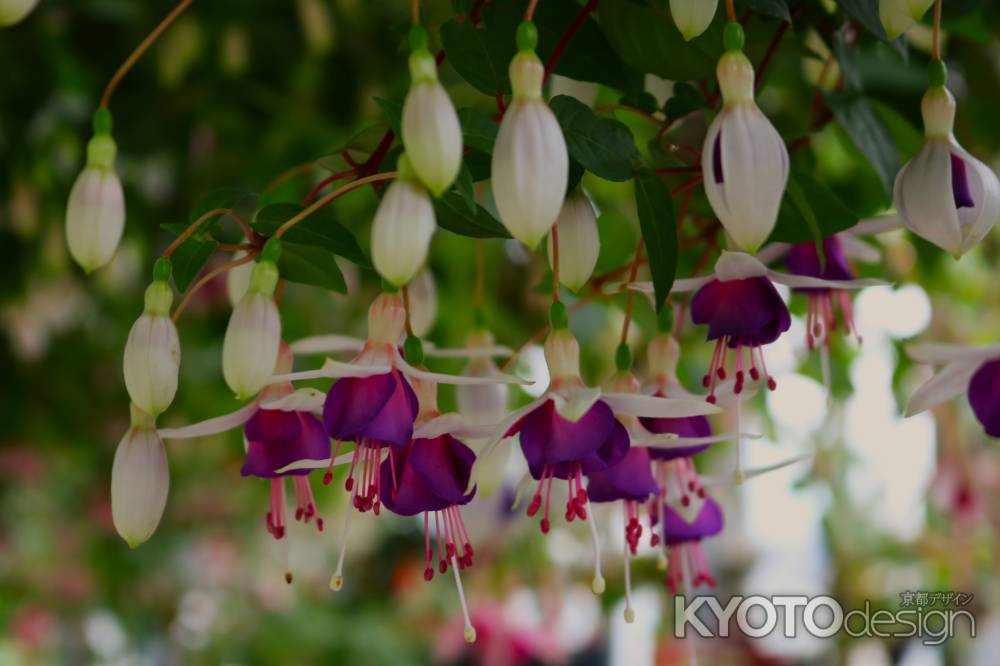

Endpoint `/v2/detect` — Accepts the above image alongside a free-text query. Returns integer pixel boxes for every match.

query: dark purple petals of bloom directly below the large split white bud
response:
[691,277,792,346]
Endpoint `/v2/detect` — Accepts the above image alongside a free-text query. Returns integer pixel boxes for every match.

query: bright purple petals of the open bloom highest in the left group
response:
[323,370,417,446]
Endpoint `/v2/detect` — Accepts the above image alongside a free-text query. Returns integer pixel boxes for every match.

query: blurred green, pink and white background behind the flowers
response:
[0,0,1000,666]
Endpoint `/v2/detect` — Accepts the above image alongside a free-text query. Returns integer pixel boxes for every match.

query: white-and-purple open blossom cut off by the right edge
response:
[906,343,1000,437]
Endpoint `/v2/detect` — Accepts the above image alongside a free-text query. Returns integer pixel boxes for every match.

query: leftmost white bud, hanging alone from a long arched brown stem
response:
[66,135,125,273]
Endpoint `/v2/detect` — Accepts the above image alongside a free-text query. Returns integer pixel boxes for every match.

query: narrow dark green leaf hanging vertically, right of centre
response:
[635,168,677,312]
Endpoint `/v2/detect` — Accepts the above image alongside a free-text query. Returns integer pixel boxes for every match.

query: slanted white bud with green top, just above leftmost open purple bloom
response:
[222,261,281,400]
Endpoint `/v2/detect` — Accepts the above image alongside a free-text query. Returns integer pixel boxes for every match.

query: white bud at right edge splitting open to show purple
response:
[893,86,1000,258]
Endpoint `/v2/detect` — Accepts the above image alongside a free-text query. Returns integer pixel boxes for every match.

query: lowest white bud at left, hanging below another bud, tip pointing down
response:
[111,405,170,548]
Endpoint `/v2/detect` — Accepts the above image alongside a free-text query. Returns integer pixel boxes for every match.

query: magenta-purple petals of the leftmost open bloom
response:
[240,409,330,479]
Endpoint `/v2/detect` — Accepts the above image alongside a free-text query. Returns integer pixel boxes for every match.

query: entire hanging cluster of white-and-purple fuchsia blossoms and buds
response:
[56,0,1000,641]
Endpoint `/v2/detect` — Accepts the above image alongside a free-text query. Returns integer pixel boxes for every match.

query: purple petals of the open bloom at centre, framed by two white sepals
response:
[512,400,617,469]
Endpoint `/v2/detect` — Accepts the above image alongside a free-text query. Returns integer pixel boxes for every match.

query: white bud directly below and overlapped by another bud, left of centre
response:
[372,169,437,287]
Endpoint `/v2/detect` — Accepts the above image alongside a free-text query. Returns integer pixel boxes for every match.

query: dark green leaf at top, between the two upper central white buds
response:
[441,19,516,96]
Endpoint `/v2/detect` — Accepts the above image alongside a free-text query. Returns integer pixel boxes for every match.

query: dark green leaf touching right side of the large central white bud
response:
[549,95,639,182]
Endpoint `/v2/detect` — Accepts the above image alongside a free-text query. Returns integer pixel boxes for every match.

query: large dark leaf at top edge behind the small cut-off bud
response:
[600,0,725,81]
